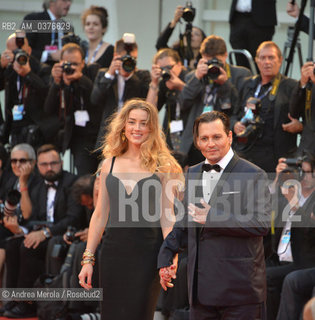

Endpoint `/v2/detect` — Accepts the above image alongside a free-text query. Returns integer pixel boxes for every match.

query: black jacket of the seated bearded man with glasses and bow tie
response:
[30,171,84,236]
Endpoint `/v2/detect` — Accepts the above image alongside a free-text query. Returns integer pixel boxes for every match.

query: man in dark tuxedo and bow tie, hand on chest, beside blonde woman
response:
[158,111,270,320]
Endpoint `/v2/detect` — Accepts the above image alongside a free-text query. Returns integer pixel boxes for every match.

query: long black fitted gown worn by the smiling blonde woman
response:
[100,172,163,320]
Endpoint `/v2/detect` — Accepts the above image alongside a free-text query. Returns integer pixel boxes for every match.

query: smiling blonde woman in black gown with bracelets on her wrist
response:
[79,99,182,320]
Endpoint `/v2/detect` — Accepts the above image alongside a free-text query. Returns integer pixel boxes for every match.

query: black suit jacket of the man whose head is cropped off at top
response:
[229,0,277,27]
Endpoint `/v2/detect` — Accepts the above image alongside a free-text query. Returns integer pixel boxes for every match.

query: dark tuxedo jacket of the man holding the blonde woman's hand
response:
[158,155,270,306]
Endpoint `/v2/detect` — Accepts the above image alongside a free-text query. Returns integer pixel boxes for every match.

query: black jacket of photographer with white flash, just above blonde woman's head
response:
[91,68,151,147]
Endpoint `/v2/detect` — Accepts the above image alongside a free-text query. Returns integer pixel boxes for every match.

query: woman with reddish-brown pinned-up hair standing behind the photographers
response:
[82,6,114,68]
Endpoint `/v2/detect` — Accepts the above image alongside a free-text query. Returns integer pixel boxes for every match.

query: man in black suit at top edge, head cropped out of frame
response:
[229,0,277,67]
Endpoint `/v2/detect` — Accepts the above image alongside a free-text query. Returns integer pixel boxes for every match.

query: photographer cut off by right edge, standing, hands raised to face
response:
[290,61,315,154]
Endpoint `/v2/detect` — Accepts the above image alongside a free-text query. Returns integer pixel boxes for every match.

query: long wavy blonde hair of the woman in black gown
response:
[103,99,182,173]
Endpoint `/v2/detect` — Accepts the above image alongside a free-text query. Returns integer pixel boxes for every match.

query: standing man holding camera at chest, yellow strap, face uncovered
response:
[234,41,303,173]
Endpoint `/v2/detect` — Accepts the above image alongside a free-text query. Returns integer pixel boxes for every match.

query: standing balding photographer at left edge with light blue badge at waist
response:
[0,31,50,147]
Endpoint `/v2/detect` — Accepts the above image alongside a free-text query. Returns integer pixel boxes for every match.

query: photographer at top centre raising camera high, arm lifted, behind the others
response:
[155,1,206,70]
